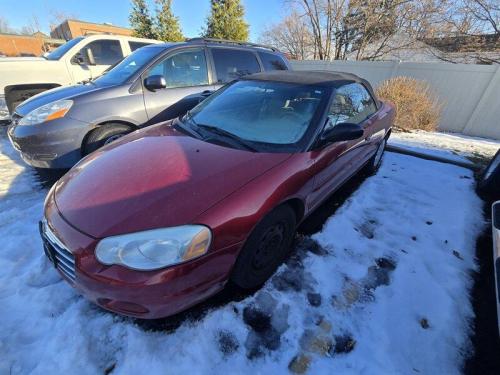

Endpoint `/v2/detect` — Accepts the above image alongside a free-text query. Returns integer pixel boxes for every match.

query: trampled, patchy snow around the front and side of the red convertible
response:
[0,131,483,374]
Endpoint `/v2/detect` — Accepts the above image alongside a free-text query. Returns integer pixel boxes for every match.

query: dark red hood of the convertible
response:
[54,123,290,238]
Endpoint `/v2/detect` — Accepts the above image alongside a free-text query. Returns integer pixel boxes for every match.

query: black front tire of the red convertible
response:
[230,205,297,289]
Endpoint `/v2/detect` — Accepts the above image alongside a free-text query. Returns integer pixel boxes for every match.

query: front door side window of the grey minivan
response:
[147,48,208,88]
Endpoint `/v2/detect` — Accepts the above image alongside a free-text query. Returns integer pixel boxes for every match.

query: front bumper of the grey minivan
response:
[7,117,91,169]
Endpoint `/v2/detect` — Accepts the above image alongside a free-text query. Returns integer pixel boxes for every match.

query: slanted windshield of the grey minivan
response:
[95,47,164,85]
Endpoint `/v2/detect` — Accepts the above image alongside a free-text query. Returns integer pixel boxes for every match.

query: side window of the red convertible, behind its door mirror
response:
[325,83,377,130]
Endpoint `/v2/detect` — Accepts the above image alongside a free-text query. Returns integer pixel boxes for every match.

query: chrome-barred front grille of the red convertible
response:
[40,219,75,282]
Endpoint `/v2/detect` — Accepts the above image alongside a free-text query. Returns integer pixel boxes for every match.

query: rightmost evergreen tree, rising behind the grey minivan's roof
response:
[203,0,248,41]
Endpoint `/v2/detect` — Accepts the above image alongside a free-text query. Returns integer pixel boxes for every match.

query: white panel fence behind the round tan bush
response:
[292,61,500,139]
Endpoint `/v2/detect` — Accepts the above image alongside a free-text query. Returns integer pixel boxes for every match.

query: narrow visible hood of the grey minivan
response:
[16,83,106,116]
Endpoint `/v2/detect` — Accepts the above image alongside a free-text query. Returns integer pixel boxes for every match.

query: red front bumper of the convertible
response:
[45,197,241,319]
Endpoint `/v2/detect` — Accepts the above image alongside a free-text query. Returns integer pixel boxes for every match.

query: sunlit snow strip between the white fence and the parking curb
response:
[389,130,500,165]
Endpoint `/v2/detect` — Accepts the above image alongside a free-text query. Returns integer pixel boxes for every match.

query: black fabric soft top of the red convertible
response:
[244,70,376,102]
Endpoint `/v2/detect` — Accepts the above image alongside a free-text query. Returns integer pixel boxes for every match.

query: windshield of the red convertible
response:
[186,80,326,151]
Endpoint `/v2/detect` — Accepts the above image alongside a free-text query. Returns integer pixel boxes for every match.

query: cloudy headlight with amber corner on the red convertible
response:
[95,225,212,271]
